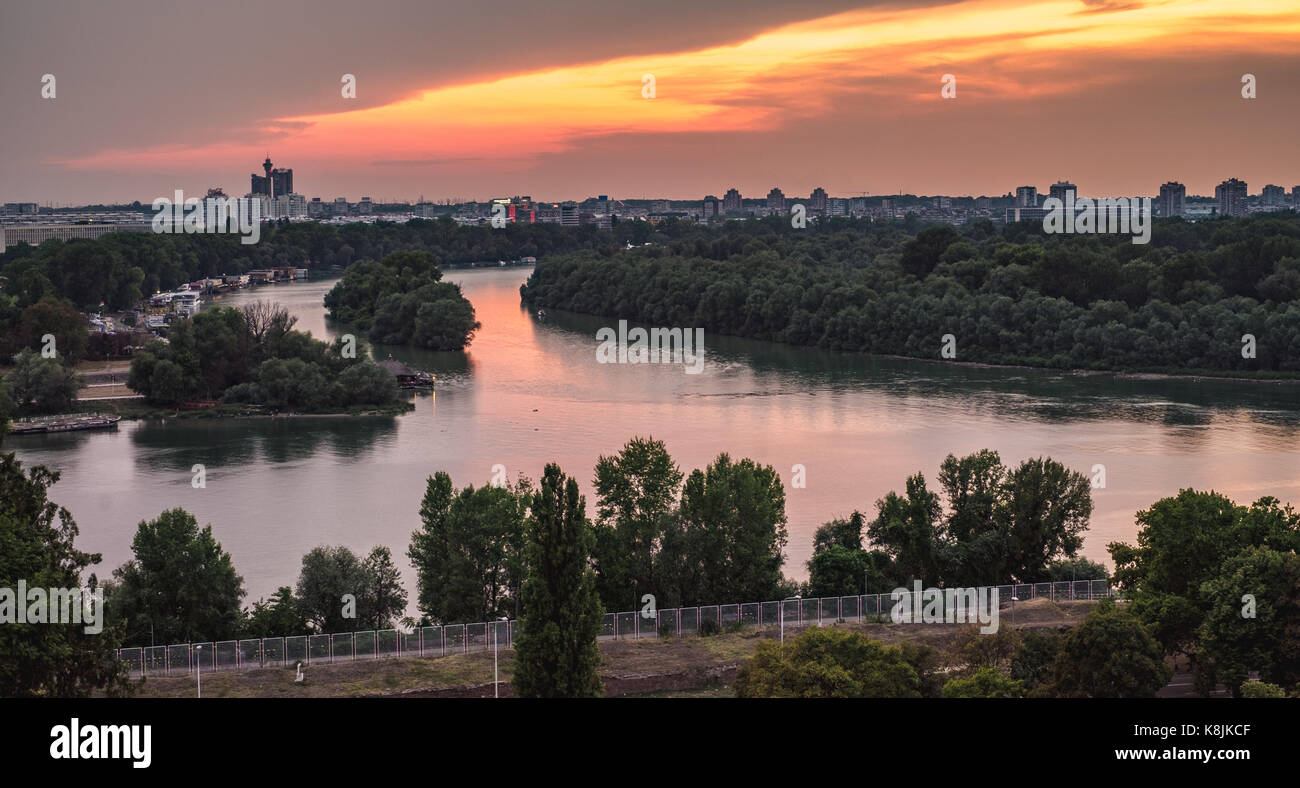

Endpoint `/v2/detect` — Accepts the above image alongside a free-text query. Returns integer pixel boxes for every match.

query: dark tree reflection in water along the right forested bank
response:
[546,309,1300,436]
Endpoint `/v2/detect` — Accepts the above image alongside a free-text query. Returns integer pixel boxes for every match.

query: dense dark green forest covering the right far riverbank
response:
[521,213,1300,374]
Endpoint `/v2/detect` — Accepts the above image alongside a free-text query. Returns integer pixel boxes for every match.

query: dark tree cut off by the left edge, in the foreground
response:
[0,457,127,697]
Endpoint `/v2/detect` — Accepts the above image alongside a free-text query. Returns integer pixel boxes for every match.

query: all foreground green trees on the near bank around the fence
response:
[0,423,1300,697]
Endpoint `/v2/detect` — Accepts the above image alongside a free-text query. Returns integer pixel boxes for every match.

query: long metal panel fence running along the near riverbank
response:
[116,580,1113,676]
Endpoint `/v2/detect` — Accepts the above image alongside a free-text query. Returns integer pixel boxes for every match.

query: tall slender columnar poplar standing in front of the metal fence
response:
[514,463,605,697]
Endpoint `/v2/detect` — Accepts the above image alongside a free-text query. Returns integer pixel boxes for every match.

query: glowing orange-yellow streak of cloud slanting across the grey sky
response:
[61,0,1300,169]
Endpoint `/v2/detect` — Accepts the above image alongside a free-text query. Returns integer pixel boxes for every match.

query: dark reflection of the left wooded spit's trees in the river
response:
[131,416,397,472]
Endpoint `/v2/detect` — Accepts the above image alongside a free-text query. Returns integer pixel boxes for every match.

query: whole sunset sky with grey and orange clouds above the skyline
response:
[0,0,1300,204]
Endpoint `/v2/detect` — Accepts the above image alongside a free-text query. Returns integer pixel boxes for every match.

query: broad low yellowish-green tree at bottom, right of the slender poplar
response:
[736,627,922,698]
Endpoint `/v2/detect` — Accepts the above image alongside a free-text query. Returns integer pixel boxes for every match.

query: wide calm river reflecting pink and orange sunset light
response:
[5,268,1300,612]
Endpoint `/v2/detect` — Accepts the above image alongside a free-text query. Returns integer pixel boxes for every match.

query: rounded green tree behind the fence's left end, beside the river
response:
[108,508,244,645]
